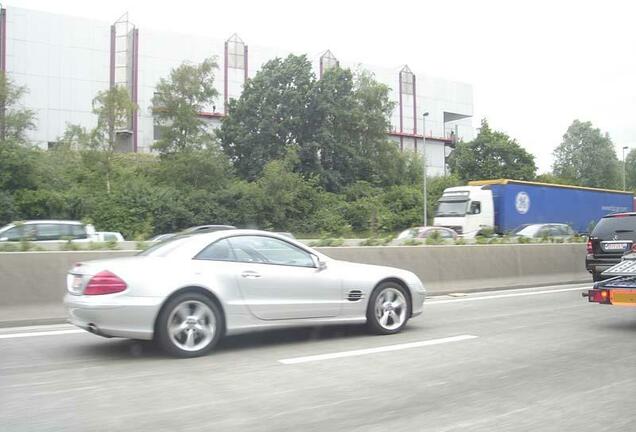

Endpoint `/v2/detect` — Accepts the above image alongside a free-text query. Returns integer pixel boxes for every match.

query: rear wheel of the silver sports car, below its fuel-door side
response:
[156,292,225,357]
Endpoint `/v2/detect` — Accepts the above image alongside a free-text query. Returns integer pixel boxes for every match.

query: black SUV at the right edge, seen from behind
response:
[585,212,636,281]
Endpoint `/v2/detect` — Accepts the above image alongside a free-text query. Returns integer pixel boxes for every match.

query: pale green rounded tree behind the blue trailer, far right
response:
[552,120,622,188]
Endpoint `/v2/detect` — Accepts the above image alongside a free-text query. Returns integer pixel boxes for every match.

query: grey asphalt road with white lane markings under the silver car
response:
[0,285,636,432]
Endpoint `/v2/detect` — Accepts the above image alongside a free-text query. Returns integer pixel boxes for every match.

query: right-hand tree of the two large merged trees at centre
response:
[300,68,400,191]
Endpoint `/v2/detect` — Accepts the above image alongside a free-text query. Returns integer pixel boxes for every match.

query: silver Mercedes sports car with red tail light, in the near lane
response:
[64,230,425,357]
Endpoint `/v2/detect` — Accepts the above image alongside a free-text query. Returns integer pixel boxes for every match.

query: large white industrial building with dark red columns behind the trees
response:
[0,7,473,174]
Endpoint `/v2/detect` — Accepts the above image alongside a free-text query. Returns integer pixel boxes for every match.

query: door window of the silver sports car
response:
[230,236,314,267]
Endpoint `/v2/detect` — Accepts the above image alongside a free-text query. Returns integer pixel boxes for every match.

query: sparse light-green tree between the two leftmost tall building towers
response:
[152,58,218,155]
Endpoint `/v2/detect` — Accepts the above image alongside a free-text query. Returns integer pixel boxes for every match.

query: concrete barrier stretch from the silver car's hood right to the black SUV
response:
[319,244,591,294]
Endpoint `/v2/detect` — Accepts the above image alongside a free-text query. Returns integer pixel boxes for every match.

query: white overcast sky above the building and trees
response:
[2,0,636,172]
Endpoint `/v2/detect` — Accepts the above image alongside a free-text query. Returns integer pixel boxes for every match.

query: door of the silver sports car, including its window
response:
[229,235,343,320]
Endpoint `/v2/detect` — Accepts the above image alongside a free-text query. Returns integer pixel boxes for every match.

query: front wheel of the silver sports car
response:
[367,282,411,335]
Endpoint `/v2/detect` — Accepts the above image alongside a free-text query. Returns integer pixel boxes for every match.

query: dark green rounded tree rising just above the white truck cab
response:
[448,119,537,182]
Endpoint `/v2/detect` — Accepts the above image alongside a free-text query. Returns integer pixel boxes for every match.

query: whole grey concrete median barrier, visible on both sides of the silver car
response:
[0,244,591,322]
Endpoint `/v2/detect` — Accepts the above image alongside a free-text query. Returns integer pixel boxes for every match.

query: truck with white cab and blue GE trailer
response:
[434,179,634,237]
